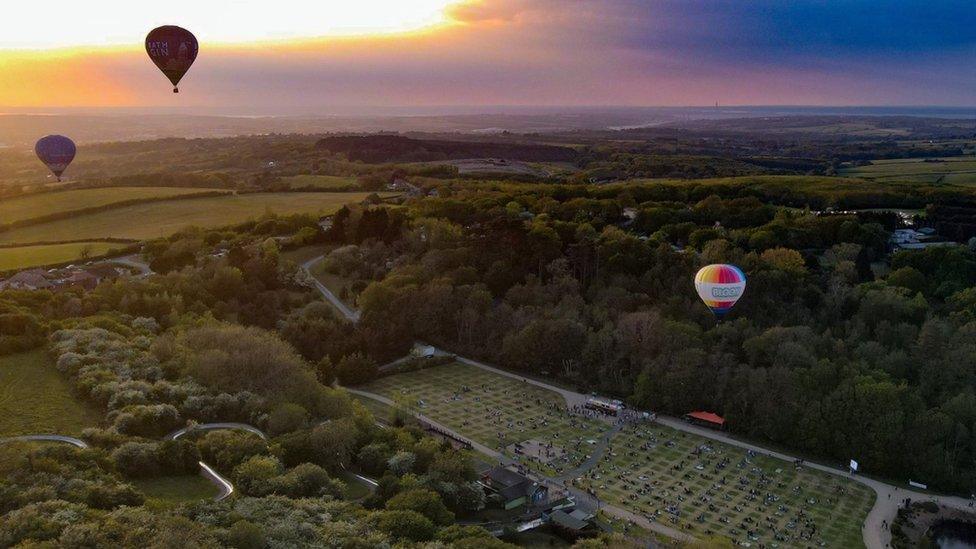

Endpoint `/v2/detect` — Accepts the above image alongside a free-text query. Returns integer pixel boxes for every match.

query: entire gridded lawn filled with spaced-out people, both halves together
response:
[362,364,874,547]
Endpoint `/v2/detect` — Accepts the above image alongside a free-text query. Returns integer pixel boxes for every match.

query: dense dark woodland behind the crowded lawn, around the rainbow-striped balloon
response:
[310,180,976,490]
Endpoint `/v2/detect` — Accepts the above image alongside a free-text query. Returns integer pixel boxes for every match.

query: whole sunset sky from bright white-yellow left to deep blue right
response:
[0,0,976,114]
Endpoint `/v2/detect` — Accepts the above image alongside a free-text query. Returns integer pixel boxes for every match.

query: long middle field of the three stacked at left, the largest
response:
[0,193,376,244]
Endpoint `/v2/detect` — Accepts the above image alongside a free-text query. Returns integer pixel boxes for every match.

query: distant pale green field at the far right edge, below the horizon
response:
[841,156,976,185]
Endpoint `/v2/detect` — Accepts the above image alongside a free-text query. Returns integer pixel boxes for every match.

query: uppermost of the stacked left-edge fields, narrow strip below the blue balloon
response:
[0,187,227,224]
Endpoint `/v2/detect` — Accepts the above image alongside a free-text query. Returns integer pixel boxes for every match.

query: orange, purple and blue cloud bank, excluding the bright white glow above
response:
[0,0,976,108]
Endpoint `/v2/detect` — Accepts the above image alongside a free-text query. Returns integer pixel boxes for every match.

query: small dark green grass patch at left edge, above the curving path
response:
[0,351,102,436]
